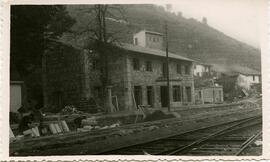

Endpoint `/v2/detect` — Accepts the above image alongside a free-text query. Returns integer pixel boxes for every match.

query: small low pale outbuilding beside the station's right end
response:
[195,86,224,104]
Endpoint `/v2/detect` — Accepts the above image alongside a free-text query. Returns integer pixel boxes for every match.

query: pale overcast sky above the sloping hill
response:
[161,0,265,47]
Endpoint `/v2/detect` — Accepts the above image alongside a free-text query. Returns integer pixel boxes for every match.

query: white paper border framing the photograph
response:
[0,0,270,162]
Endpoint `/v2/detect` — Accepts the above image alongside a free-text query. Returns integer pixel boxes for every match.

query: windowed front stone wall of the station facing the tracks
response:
[124,52,195,108]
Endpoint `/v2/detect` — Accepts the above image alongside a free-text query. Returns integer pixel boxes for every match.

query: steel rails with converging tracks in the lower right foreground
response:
[97,116,262,156]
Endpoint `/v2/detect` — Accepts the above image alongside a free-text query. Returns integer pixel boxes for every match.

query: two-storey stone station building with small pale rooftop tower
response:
[44,31,195,111]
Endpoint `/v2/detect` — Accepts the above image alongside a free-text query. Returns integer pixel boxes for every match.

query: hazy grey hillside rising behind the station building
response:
[65,5,260,70]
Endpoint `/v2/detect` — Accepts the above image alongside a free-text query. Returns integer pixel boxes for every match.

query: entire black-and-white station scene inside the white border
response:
[1,0,267,158]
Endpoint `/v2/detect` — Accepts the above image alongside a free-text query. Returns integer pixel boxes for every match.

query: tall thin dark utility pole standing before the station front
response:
[165,20,171,111]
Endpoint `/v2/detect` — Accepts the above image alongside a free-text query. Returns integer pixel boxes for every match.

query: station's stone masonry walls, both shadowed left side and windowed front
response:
[46,46,194,110]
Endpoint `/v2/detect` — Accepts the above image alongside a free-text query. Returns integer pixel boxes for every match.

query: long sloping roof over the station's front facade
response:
[118,43,194,62]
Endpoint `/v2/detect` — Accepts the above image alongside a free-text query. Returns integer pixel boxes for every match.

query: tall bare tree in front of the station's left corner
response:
[71,4,128,112]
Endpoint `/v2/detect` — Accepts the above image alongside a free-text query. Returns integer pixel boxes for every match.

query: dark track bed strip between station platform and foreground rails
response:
[10,109,261,155]
